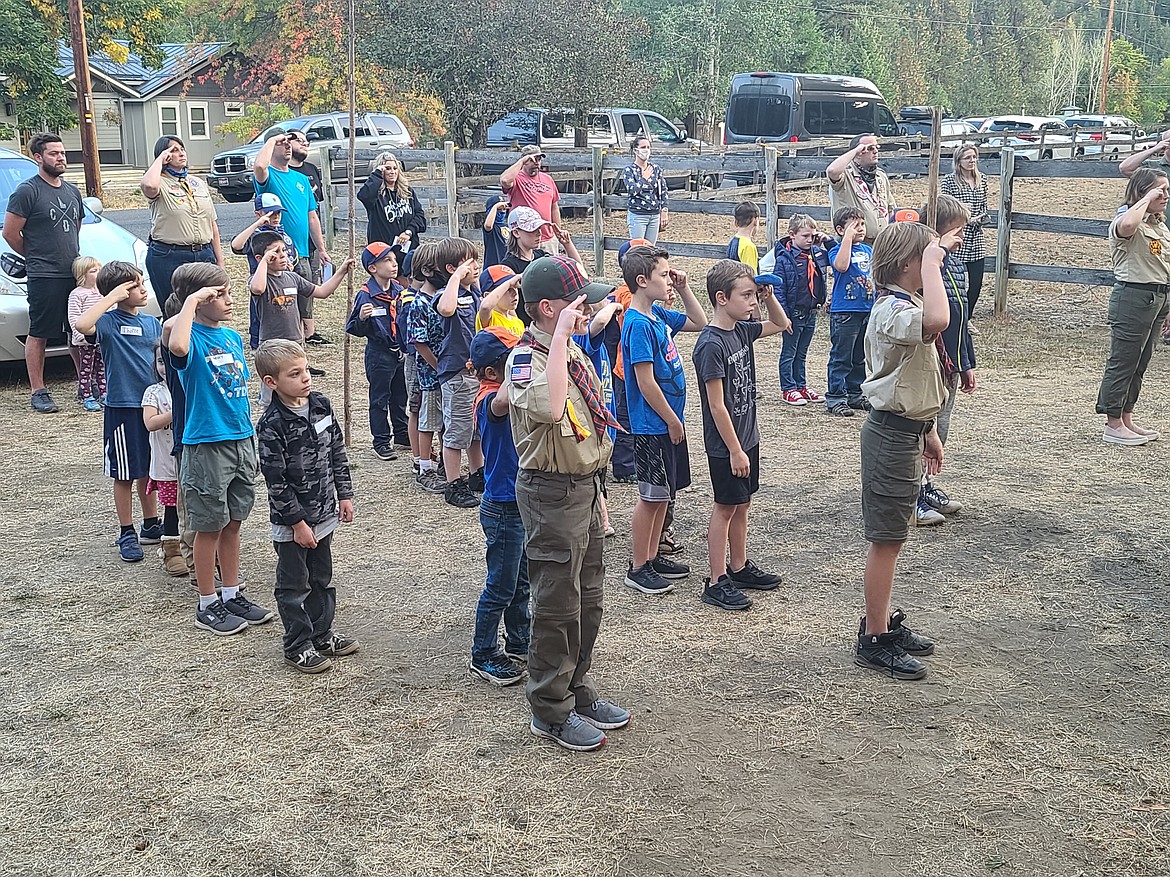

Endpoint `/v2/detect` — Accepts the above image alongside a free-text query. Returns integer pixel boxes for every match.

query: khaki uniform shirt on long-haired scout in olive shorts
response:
[861,289,947,421]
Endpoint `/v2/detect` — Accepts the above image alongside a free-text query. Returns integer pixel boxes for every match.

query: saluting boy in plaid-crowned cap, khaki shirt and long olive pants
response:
[504,256,629,752]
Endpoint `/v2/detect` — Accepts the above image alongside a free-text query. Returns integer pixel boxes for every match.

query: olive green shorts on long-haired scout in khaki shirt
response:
[861,412,925,543]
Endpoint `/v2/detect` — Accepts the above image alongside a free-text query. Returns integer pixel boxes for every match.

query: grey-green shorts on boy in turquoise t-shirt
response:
[179,437,256,533]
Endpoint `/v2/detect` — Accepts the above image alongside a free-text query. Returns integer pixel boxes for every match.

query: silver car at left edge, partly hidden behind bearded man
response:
[0,147,160,362]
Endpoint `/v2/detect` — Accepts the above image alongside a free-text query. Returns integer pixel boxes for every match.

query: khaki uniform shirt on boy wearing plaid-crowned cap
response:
[504,324,613,475]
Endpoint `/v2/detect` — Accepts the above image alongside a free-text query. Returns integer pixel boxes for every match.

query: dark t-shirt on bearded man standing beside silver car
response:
[8,174,85,277]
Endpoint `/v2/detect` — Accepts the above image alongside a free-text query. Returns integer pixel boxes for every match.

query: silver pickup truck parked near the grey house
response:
[207,112,414,202]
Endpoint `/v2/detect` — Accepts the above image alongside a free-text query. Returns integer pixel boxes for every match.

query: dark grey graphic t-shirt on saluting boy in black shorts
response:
[691,320,763,457]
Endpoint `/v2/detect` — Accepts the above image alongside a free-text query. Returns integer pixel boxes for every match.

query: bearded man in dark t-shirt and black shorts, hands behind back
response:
[4,133,84,414]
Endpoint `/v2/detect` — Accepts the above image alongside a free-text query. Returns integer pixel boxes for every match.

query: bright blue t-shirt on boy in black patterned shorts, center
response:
[621,304,687,435]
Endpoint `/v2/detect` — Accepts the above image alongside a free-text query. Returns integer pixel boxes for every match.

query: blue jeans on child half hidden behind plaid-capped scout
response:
[472,497,532,658]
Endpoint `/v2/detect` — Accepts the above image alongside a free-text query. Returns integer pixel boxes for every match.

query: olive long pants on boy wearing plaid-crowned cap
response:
[516,469,605,725]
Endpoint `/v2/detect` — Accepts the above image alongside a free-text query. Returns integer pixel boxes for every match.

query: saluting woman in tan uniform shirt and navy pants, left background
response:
[140,137,223,313]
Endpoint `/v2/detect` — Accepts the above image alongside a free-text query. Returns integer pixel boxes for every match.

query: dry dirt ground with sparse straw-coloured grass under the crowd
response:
[0,175,1170,877]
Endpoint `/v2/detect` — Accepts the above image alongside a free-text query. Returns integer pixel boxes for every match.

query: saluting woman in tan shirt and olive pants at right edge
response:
[1096,167,1170,446]
